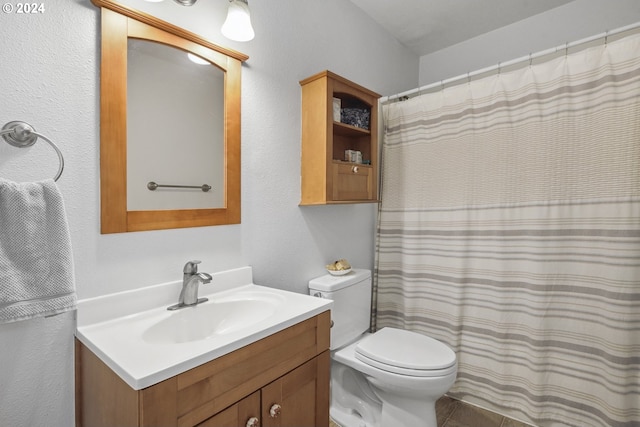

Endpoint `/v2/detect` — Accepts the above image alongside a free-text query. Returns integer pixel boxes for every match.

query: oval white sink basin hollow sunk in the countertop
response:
[142,292,284,344]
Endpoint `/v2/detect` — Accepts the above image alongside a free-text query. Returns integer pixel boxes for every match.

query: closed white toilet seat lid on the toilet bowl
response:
[355,328,457,377]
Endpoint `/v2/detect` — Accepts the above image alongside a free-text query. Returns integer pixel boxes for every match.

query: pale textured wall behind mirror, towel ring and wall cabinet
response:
[0,0,418,427]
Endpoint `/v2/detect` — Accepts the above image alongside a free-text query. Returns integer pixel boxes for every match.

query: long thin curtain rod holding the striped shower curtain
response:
[380,22,640,105]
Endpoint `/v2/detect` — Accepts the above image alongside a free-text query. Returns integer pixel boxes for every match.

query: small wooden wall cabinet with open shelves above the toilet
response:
[300,71,380,205]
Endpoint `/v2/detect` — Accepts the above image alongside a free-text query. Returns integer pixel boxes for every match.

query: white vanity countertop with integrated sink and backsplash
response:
[76,267,332,390]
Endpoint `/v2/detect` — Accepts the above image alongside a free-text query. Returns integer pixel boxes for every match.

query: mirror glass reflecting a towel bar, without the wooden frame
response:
[127,38,224,211]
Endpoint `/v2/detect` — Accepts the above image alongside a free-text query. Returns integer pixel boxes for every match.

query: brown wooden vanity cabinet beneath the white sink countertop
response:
[76,311,330,427]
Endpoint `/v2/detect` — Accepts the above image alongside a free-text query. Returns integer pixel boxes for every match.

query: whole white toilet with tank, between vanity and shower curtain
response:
[309,269,458,427]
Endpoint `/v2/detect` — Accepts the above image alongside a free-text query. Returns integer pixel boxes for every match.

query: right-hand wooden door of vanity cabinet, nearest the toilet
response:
[262,351,329,427]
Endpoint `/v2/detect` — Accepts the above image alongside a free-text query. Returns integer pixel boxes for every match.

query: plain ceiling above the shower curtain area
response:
[351,0,572,56]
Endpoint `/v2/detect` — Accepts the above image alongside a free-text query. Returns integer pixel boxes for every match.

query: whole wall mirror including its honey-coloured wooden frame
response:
[92,0,248,234]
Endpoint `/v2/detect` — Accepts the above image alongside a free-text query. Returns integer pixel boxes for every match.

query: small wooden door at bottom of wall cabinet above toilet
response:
[333,163,373,201]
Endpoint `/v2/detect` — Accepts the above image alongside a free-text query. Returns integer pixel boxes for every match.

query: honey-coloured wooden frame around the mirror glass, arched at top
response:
[92,0,249,234]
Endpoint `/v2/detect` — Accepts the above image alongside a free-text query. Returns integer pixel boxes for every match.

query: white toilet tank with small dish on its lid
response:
[309,268,371,350]
